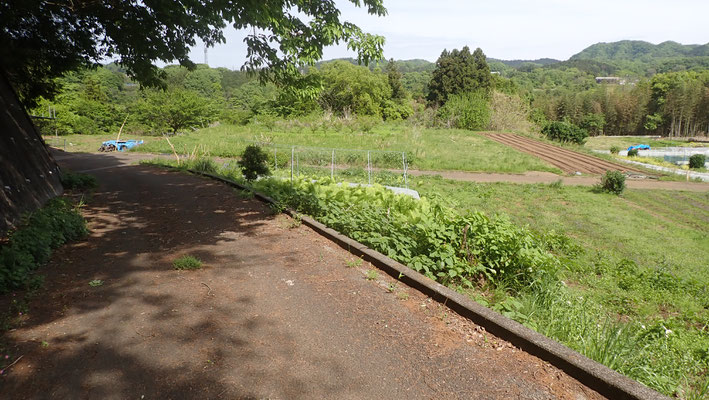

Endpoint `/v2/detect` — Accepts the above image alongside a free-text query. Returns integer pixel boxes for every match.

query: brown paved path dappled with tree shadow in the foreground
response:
[0,154,600,400]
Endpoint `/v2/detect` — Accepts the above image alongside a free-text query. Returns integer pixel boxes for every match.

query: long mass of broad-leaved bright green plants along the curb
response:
[255,179,558,289]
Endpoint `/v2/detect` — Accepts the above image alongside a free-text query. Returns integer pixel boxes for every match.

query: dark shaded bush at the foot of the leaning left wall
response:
[0,198,88,293]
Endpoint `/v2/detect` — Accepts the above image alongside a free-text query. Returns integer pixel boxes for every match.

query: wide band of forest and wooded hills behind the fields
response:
[35,41,709,136]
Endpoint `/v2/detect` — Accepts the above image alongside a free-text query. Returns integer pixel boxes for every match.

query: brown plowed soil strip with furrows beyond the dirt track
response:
[484,133,647,175]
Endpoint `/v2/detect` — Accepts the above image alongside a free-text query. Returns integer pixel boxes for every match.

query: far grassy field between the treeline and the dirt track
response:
[50,123,561,173]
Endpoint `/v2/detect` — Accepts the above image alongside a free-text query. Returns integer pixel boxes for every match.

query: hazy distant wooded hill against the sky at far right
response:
[569,40,709,61]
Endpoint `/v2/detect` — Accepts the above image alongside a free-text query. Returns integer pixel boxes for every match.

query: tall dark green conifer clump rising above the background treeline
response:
[428,46,492,105]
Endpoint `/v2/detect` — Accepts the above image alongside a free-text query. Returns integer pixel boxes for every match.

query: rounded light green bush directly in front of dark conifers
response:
[438,91,490,131]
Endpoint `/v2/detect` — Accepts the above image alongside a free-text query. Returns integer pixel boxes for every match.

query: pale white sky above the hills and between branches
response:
[181,0,709,69]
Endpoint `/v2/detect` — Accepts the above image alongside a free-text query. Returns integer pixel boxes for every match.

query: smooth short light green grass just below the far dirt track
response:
[412,178,709,290]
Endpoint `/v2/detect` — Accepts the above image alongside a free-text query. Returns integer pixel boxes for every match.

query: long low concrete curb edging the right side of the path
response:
[190,170,669,400]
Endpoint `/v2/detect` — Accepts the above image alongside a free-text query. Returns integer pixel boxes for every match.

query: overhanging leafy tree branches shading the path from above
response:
[0,0,386,106]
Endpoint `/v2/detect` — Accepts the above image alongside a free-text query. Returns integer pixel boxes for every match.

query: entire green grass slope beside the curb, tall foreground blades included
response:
[413,178,709,398]
